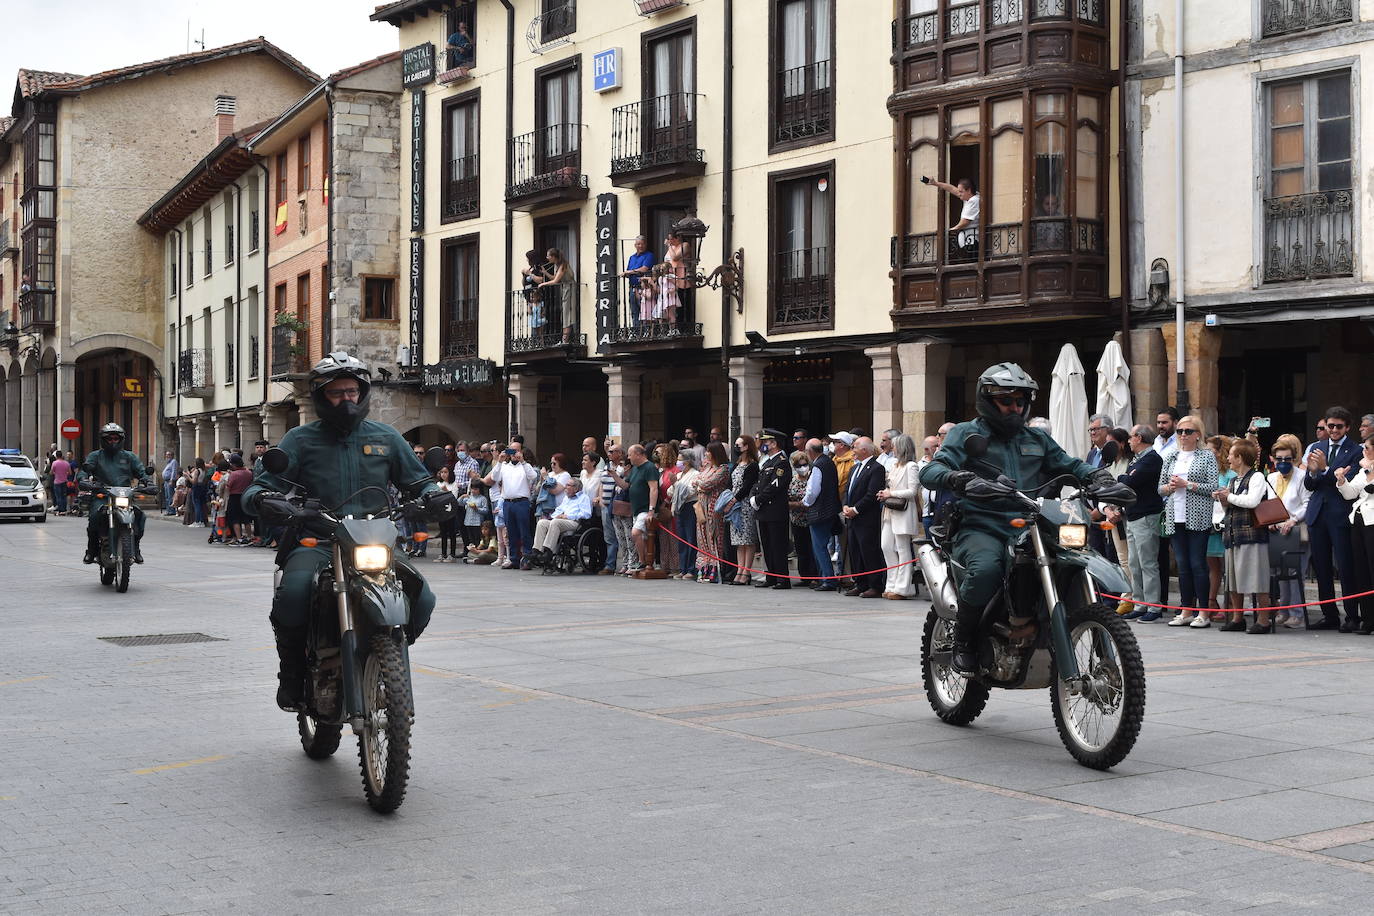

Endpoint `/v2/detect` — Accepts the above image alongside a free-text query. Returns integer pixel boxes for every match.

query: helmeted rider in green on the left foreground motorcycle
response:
[242,350,452,711]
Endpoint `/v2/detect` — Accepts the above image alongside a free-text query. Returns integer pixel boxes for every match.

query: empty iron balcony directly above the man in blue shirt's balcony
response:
[610,92,706,188]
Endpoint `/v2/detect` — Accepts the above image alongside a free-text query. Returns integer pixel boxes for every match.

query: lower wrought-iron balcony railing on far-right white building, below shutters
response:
[1263,190,1355,283]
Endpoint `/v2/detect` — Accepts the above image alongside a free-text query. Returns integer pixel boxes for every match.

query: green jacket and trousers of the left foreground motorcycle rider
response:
[243,420,440,637]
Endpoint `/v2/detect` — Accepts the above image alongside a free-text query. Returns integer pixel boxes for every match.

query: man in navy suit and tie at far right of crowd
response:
[1303,407,1362,633]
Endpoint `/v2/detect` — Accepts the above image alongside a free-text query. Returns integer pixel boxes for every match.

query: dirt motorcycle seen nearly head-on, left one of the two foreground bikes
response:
[262,448,452,813]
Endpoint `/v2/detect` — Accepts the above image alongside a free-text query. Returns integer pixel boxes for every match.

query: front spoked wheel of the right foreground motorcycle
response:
[1050,606,1145,769]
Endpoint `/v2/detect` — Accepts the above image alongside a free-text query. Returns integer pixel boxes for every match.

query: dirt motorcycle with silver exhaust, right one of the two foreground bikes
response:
[916,435,1145,769]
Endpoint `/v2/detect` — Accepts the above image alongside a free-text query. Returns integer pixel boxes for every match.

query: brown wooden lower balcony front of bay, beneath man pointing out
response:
[892,217,1107,328]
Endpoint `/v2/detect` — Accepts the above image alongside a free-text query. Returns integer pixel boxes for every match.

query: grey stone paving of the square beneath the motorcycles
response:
[0,518,1374,915]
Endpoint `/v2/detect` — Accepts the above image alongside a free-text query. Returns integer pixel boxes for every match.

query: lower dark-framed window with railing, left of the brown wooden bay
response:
[768,163,835,331]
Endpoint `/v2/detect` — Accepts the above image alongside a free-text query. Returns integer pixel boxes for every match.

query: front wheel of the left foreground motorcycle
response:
[357,630,414,814]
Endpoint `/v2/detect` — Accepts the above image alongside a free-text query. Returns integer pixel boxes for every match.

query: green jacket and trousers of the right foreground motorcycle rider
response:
[921,417,1094,608]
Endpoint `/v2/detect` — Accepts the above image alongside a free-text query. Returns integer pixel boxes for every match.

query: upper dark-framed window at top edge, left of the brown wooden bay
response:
[769,0,834,151]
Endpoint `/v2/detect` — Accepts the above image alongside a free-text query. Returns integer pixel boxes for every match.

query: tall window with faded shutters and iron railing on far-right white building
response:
[1263,71,1355,283]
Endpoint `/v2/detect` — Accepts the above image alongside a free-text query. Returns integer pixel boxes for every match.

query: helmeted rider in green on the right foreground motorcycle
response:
[921,363,1114,674]
